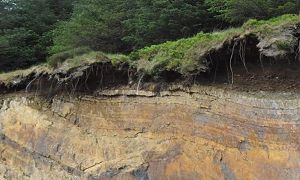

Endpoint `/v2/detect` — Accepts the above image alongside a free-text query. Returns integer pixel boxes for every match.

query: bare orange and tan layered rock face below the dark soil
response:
[0,87,300,180]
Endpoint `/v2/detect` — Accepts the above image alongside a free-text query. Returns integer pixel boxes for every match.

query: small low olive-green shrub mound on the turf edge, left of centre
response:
[47,47,92,67]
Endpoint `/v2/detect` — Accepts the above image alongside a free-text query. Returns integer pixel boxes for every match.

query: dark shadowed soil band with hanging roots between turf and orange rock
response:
[7,32,300,98]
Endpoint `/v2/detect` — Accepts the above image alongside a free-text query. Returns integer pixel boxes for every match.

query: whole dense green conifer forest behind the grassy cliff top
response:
[0,0,300,71]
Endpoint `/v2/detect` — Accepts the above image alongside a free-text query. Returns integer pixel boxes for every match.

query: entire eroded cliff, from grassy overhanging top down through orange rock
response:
[0,16,300,180]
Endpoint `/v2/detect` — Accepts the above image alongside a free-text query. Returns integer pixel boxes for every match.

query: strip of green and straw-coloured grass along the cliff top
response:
[0,15,300,82]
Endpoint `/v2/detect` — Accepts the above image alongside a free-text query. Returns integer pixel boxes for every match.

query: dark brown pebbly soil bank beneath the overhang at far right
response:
[219,63,300,92]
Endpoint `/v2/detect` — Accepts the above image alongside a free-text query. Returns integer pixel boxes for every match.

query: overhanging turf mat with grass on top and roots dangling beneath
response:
[0,15,300,91]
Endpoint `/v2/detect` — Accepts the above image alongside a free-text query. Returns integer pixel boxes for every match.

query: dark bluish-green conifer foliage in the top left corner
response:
[0,0,71,70]
